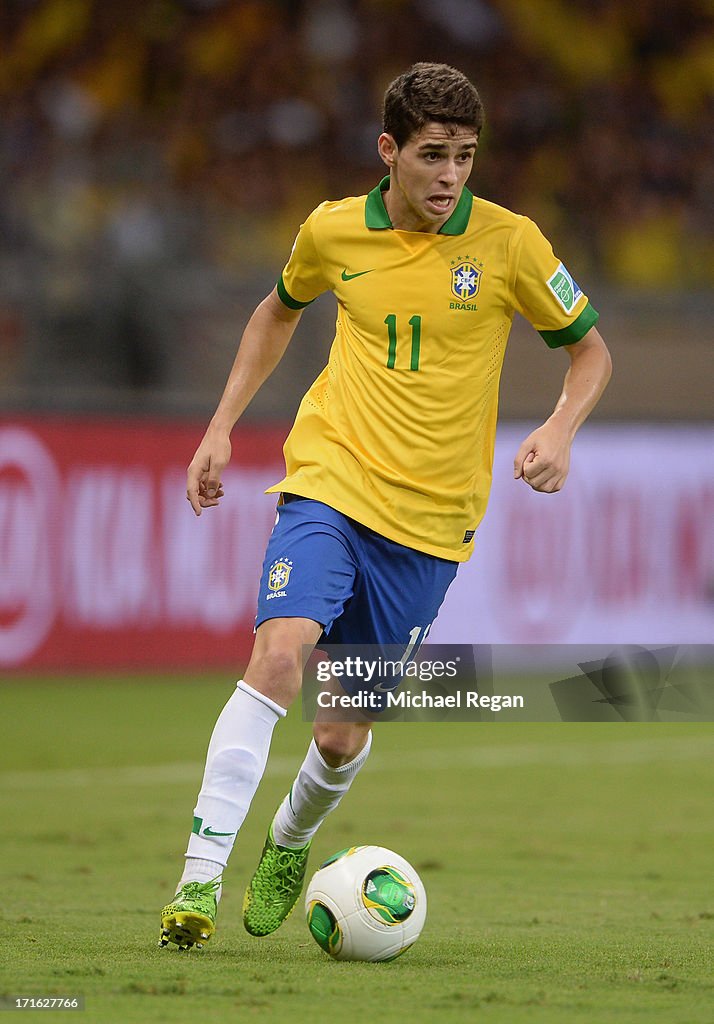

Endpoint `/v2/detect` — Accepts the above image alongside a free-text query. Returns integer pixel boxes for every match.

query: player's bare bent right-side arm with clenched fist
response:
[513,327,612,494]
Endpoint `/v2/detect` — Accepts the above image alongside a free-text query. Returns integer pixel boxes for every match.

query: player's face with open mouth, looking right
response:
[377,121,478,232]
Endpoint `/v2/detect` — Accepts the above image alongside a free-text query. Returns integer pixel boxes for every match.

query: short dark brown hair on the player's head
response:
[383,61,484,147]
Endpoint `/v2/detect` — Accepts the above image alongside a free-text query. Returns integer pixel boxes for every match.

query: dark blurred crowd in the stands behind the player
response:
[0,0,714,385]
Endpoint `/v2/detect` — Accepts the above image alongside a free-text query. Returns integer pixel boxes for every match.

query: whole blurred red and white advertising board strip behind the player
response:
[0,419,714,674]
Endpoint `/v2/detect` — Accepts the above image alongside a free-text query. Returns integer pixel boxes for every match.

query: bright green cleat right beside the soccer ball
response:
[243,825,311,935]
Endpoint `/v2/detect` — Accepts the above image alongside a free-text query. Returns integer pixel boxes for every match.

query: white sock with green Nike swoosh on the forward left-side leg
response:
[184,680,287,881]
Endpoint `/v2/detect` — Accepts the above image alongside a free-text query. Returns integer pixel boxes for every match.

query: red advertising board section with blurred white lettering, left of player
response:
[0,419,286,672]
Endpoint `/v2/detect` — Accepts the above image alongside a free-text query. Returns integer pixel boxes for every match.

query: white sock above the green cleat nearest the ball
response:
[272,732,372,849]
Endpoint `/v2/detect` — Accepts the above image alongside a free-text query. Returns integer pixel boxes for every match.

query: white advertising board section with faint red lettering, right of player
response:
[429,423,714,645]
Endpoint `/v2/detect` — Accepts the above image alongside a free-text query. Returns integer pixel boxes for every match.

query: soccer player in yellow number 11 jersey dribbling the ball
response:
[160,63,611,948]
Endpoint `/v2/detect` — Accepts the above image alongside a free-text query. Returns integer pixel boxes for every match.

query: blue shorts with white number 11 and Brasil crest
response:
[255,495,459,647]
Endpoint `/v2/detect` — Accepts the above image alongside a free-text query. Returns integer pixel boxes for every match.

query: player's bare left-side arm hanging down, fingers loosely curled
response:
[186,289,301,515]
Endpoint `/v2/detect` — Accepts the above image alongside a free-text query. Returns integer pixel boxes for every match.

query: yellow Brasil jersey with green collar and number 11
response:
[269,177,598,561]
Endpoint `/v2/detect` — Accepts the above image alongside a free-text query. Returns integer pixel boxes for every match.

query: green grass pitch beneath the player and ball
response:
[0,676,714,1024]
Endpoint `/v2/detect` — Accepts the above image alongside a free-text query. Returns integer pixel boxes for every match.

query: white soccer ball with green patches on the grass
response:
[305,846,426,963]
